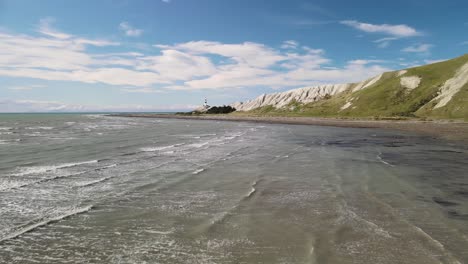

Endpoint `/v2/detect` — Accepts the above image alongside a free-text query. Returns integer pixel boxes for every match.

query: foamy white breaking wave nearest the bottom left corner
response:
[0,205,94,243]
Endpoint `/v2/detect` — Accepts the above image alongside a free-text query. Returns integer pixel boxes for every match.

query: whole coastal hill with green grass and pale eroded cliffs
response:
[231,54,468,120]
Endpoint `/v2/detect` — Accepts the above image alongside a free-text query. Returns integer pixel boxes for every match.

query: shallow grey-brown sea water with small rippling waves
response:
[0,115,468,263]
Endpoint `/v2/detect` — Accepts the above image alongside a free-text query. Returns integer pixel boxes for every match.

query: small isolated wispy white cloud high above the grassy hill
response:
[340,20,422,38]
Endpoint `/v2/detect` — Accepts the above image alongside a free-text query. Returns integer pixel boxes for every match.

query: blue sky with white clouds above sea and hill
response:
[0,0,468,112]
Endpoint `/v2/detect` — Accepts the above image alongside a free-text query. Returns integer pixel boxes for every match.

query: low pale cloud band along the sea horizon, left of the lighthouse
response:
[0,100,197,113]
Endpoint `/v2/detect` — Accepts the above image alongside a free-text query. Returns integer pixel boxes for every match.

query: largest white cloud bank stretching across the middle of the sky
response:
[0,20,388,93]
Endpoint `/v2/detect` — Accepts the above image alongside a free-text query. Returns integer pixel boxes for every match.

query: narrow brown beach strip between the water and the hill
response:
[109,113,468,145]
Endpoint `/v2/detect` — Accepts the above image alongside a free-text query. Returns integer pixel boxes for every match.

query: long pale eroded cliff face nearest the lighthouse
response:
[231,84,352,111]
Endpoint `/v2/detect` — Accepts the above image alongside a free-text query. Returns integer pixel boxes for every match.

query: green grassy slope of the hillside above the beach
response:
[241,55,468,119]
